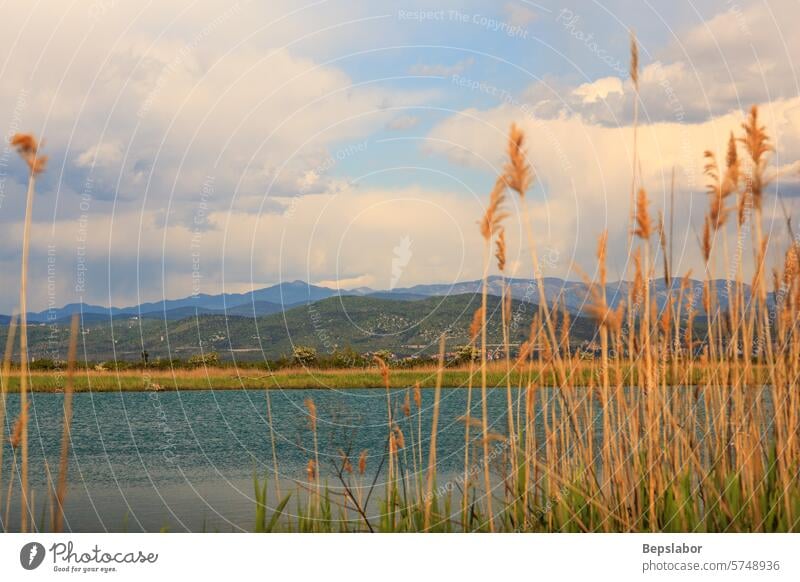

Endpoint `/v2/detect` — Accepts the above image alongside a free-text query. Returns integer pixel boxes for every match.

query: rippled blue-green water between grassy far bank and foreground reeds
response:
[2,389,532,531]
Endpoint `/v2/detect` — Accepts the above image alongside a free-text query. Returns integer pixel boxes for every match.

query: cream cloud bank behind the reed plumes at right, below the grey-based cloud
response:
[425,97,800,277]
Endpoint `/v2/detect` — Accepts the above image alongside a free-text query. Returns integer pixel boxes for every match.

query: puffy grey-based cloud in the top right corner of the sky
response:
[525,0,800,126]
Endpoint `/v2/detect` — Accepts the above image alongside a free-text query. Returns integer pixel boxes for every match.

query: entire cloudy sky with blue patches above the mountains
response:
[0,0,800,313]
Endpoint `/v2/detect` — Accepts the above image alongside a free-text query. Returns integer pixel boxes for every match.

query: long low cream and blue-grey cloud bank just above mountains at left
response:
[0,186,548,313]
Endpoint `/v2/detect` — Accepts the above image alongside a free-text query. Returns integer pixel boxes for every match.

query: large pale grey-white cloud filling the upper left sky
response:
[0,0,424,214]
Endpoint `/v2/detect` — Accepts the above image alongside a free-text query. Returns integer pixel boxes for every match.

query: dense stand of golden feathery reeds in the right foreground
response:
[245,100,800,532]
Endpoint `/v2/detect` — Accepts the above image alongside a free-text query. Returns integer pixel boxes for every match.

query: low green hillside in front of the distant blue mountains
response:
[2,294,595,361]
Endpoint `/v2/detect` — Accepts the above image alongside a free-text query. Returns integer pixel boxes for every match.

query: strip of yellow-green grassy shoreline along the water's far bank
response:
[0,362,765,393]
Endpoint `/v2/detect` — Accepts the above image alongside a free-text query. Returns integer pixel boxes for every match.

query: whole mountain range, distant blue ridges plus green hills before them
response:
[0,277,749,361]
